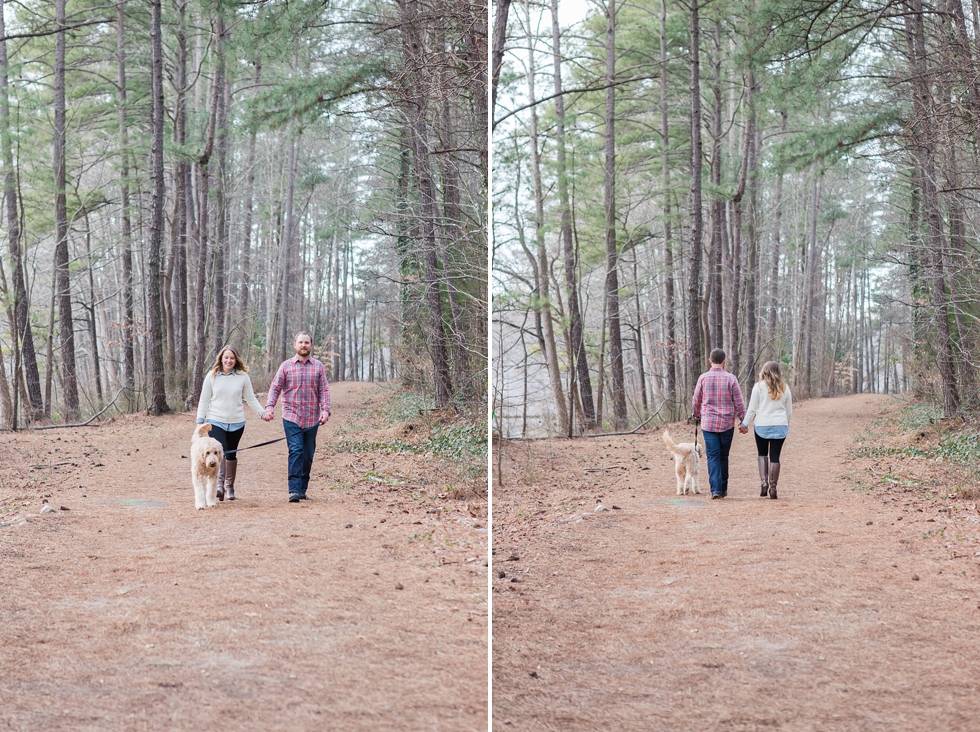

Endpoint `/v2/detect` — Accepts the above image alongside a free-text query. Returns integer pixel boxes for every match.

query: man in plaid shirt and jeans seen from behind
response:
[692,348,747,500]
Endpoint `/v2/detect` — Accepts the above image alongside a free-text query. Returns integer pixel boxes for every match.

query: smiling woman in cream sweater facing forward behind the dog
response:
[197,346,264,501]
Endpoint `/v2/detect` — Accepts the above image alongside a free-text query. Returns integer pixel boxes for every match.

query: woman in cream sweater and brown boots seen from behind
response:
[740,361,793,499]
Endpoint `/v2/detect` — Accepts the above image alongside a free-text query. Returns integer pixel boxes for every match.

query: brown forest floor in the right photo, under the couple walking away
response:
[492,395,980,732]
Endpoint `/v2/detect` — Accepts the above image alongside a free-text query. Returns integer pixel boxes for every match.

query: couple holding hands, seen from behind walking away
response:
[692,348,793,500]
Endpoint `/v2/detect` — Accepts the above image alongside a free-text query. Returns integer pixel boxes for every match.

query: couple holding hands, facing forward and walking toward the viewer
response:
[197,332,330,503]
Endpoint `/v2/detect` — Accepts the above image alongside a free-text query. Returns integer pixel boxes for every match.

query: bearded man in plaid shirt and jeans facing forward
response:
[262,332,330,503]
